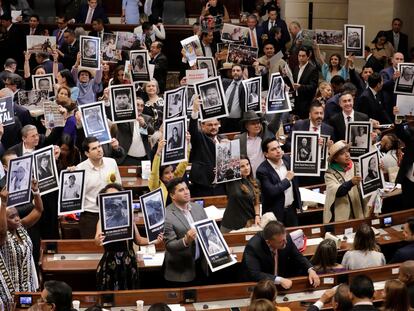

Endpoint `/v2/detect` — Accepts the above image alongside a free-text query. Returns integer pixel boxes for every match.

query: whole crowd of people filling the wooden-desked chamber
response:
[0,0,414,311]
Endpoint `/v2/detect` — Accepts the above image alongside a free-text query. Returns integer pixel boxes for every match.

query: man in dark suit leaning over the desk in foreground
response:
[242,221,320,289]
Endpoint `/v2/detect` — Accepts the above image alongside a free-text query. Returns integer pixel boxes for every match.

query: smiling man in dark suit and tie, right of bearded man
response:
[329,92,369,141]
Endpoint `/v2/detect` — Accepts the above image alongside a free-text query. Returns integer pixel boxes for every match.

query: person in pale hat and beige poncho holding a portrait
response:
[323,140,368,223]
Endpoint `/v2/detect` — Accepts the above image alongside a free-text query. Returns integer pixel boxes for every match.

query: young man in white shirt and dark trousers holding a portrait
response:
[76,137,121,239]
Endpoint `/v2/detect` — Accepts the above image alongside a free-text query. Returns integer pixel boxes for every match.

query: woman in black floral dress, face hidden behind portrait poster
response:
[95,184,163,290]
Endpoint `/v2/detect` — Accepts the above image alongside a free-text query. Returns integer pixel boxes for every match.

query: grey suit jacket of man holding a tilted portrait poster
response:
[163,203,207,282]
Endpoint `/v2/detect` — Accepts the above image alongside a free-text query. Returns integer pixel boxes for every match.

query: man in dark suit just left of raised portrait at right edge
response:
[380,52,404,115]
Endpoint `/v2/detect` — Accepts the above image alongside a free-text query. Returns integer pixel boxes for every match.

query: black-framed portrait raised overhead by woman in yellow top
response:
[161,116,187,165]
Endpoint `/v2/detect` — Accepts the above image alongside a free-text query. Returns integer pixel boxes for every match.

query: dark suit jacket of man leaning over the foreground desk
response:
[242,232,312,282]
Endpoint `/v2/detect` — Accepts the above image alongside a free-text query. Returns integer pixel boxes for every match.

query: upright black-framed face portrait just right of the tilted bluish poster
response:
[109,84,138,123]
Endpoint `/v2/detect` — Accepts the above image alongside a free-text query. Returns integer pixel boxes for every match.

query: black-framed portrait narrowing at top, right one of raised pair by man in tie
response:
[266,72,292,113]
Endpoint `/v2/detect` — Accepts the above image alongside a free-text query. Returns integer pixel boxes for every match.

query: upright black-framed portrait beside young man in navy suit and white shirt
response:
[290,131,321,176]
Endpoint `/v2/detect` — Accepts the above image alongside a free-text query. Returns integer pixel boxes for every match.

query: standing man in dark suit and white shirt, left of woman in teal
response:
[293,47,319,119]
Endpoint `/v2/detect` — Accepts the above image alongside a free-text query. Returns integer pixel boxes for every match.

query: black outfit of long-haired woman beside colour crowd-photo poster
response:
[221,178,255,230]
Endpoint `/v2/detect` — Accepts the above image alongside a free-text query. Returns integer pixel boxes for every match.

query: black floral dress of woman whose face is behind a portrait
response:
[96,240,139,290]
